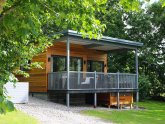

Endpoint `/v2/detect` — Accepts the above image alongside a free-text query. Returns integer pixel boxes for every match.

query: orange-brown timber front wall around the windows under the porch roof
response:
[47,42,107,73]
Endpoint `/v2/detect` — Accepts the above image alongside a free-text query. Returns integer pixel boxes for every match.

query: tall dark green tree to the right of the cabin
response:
[127,2,165,97]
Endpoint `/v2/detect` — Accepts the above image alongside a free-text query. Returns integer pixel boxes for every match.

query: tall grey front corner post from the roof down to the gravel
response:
[66,37,70,107]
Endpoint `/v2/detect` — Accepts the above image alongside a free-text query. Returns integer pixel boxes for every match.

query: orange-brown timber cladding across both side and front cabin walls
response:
[17,39,107,92]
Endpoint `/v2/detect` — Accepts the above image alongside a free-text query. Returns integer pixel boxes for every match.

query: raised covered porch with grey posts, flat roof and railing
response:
[47,30,142,108]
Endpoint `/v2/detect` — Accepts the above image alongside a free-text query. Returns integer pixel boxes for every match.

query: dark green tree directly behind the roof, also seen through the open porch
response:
[98,0,135,73]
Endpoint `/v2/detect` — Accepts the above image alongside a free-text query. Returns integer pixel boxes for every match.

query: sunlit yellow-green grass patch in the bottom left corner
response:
[0,111,39,124]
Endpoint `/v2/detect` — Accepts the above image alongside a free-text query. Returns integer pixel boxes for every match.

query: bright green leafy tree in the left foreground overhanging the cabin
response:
[0,0,106,113]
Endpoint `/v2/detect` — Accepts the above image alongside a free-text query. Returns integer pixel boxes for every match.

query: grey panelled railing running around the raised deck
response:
[48,71,137,90]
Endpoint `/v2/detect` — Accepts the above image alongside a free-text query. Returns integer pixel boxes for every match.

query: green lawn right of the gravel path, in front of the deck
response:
[82,101,165,124]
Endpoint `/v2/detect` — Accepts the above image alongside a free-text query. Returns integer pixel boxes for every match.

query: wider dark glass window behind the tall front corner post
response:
[52,56,82,72]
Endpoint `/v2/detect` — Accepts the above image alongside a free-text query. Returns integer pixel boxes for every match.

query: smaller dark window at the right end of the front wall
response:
[87,60,104,72]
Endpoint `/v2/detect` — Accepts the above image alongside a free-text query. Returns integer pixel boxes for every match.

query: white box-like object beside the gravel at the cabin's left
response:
[4,82,29,103]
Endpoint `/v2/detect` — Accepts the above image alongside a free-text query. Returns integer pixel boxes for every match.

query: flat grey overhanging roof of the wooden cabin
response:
[57,30,143,51]
